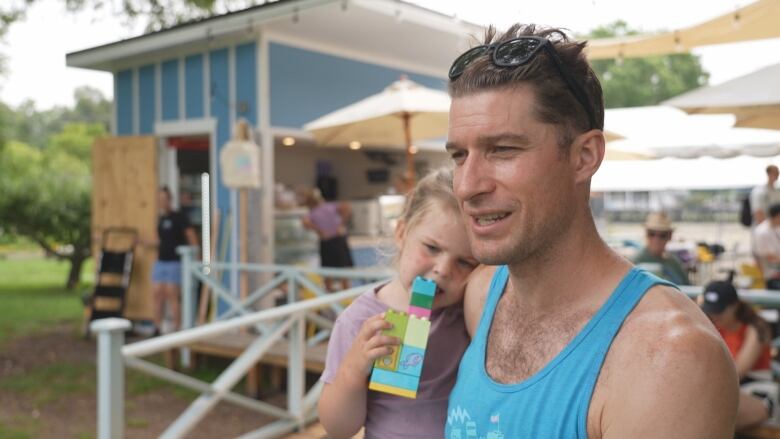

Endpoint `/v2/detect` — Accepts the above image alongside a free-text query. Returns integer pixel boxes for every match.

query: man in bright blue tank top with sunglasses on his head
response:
[445,25,737,439]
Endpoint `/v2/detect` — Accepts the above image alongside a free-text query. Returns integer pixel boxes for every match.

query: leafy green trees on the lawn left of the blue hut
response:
[0,89,111,288]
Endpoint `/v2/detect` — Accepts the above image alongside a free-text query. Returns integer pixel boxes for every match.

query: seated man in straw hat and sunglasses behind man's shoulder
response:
[633,212,690,285]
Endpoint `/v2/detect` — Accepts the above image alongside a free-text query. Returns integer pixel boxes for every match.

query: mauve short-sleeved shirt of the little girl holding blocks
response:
[321,290,469,439]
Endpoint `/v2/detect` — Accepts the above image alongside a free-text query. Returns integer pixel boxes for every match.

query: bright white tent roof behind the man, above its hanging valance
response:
[605,106,780,159]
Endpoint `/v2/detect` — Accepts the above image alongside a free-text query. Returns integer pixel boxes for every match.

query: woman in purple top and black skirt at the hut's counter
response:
[303,189,354,291]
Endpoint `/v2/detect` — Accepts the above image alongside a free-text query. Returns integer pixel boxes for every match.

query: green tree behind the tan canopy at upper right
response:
[588,21,709,108]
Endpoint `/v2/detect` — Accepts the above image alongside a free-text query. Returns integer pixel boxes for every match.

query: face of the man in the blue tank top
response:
[447,86,577,264]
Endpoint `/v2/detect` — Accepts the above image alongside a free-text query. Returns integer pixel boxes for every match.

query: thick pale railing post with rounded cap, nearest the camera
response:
[90,318,133,439]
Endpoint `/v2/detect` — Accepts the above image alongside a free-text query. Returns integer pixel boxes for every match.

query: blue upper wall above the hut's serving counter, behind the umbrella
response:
[269,43,447,127]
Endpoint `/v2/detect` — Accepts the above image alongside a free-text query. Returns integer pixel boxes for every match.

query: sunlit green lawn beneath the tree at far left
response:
[0,257,93,346]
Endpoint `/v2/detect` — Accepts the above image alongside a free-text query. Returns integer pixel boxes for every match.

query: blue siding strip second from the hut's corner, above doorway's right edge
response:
[209,49,230,213]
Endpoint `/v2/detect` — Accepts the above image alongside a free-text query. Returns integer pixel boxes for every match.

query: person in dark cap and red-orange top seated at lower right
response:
[699,281,772,430]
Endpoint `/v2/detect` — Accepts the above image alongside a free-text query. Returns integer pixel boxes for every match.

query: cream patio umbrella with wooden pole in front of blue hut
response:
[303,75,450,182]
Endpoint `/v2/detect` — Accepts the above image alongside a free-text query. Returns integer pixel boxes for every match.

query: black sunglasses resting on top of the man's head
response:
[449,36,600,129]
